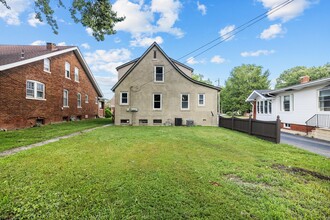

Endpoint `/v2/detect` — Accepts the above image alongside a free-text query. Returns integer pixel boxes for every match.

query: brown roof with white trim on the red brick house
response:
[0,45,103,96]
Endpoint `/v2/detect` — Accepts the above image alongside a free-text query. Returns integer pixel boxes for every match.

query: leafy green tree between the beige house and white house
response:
[221,64,270,113]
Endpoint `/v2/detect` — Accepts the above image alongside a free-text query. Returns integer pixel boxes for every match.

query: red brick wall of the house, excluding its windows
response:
[0,52,98,129]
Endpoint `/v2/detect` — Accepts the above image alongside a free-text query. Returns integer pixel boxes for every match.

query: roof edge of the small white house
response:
[245,77,330,102]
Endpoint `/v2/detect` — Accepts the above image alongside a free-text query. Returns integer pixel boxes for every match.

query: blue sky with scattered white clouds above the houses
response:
[0,0,330,98]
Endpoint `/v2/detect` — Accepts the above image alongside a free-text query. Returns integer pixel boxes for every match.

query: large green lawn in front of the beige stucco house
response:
[0,127,330,219]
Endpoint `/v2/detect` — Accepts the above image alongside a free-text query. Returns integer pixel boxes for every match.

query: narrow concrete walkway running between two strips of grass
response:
[0,124,113,157]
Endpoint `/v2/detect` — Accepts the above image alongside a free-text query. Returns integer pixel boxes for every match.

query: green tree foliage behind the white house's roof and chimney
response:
[275,63,330,89]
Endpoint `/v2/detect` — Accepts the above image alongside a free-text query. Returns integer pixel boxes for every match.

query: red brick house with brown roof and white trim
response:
[0,43,103,129]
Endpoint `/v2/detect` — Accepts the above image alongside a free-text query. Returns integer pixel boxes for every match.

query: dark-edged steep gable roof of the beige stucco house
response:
[111,42,221,91]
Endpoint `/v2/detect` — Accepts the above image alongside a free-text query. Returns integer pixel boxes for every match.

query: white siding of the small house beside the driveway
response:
[256,84,330,125]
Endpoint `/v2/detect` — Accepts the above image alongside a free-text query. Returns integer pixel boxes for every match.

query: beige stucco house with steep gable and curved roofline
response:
[112,43,220,126]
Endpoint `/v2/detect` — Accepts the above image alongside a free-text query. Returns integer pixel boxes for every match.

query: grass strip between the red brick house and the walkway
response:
[0,118,111,152]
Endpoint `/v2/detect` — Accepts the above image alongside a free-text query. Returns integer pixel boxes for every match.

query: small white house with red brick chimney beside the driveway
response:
[246,76,330,136]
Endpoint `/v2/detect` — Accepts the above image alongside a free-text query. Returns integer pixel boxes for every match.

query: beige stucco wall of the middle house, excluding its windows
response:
[115,44,217,126]
